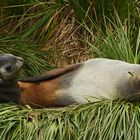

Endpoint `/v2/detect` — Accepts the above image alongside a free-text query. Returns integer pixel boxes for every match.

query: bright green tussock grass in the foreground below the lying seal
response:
[0,100,140,140]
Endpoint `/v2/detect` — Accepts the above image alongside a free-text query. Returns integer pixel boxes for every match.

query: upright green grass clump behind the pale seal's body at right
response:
[83,8,140,63]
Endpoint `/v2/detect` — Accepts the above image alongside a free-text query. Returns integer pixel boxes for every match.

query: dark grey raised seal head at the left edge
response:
[0,53,24,84]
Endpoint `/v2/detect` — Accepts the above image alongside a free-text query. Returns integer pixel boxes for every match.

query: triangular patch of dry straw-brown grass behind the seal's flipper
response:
[43,11,92,67]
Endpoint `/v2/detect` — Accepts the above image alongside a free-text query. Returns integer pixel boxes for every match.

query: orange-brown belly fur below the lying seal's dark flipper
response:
[18,79,59,107]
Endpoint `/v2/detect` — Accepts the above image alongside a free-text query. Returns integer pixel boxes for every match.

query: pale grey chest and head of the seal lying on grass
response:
[57,58,140,105]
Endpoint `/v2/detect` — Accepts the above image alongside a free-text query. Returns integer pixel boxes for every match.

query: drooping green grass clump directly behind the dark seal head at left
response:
[0,37,55,78]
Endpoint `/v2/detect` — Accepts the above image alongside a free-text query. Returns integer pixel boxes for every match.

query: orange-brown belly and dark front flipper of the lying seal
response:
[18,64,81,108]
